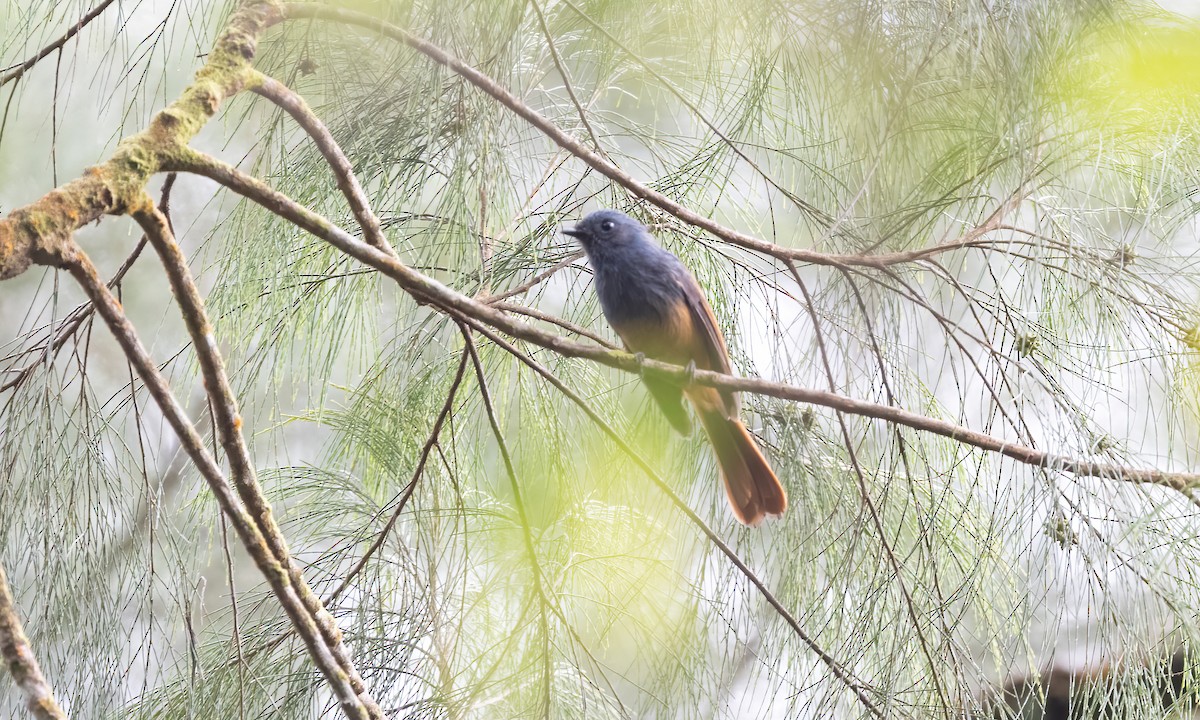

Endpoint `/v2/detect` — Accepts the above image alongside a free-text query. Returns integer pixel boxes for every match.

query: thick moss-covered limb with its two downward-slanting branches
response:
[0,0,383,719]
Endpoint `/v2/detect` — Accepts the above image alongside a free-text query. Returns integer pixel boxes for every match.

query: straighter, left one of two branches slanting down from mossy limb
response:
[65,247,379,720]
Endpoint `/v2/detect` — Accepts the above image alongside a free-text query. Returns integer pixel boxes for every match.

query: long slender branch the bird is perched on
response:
[172,151,1200,492]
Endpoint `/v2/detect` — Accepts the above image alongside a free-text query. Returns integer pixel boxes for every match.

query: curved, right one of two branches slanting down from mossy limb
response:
[132,198,383,718]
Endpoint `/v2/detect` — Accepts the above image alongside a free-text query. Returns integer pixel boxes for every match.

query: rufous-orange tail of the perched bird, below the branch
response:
[700,409,787,527]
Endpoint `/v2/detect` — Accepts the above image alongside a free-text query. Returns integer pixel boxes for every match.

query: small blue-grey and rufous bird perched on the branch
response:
[563,210,787,527]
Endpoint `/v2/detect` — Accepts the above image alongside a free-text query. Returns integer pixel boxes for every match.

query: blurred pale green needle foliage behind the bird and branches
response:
[0,0,1200,718]
